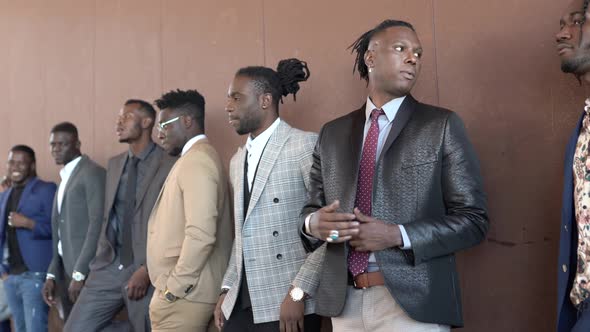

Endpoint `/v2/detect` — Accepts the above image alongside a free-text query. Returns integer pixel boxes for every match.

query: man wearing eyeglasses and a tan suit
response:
[147,90,232,332]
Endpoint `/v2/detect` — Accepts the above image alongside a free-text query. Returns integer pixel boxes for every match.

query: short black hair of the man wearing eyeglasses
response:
[155,89,205,132]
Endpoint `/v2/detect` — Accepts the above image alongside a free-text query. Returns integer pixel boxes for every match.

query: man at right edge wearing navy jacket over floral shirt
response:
[555,0,590,332]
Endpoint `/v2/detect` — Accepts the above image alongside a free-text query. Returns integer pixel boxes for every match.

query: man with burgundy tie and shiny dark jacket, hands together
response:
[301,20,488,332]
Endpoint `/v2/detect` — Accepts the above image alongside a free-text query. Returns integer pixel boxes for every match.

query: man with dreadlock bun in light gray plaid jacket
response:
[215,59,321,332]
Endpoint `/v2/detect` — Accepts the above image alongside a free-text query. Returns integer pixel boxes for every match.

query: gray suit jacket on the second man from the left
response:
[47,155,105,280]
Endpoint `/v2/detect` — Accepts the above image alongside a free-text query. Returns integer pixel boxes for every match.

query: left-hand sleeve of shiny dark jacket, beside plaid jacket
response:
[299,127,326,251]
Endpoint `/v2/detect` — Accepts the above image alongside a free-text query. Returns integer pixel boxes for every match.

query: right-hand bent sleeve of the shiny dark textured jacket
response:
[404,113,489,265]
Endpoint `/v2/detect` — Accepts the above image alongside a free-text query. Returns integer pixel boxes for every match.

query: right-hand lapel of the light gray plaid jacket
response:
[242,120,291,222]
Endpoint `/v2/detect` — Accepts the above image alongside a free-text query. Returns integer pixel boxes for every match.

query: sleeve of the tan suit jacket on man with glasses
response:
[166,151,221,297]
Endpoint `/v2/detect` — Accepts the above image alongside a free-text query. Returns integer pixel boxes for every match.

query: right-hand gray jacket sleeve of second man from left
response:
[74,167,106,276]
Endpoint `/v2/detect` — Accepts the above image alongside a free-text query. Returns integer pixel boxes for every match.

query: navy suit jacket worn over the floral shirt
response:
[557,113,584,332]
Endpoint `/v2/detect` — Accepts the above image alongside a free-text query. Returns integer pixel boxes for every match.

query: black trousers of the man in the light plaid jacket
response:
[223,305,322,332]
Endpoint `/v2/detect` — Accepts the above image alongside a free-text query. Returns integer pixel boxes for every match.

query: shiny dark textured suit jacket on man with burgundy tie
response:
[301,95,488,326]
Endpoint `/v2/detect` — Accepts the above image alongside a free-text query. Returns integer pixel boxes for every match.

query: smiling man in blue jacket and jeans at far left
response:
[0,145,56,332]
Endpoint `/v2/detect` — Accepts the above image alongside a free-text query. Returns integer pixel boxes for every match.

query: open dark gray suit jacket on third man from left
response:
[90,146,177,270]
